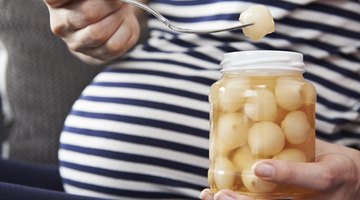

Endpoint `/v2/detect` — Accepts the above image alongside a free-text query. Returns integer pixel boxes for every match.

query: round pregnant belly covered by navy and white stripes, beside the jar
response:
[59,68,209,199]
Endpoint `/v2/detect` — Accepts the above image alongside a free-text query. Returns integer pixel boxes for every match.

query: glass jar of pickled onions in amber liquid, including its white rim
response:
[208,51,316,199]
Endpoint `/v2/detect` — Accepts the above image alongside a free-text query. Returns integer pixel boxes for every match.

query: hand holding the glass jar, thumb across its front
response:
[200,140,360,200]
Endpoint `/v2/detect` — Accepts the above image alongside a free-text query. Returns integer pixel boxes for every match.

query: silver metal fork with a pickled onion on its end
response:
[120,0,254,34]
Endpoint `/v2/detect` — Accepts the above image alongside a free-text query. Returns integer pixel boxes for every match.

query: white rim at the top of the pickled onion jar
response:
[220,50,305,72]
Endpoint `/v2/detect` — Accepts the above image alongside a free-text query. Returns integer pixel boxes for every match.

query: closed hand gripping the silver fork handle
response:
[44,0,148,64]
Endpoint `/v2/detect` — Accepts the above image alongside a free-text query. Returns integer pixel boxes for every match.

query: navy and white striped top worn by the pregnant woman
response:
[59,0,360,199]
